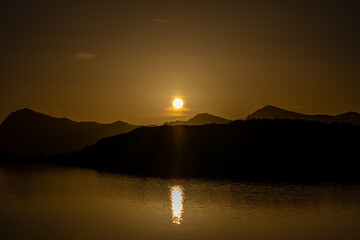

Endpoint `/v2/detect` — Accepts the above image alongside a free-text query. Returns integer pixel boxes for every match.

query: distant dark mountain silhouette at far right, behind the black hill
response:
[245,105,360,125]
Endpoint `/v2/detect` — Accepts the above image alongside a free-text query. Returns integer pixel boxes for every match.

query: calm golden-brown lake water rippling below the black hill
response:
[0,165,360,240]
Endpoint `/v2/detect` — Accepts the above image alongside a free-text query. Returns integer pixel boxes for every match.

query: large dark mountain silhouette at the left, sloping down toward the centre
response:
[0,108,138,156]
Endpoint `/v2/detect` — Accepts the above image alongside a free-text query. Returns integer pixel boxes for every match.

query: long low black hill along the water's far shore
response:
[55,120,360,181]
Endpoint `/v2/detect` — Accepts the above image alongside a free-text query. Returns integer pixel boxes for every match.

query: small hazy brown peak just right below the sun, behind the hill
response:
[164,113,231,126]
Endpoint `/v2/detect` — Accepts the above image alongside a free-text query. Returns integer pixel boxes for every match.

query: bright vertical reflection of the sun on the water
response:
[170,185,184,224]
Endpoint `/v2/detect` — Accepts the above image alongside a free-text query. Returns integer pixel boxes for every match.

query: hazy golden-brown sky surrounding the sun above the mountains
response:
[0,0,360,124]
